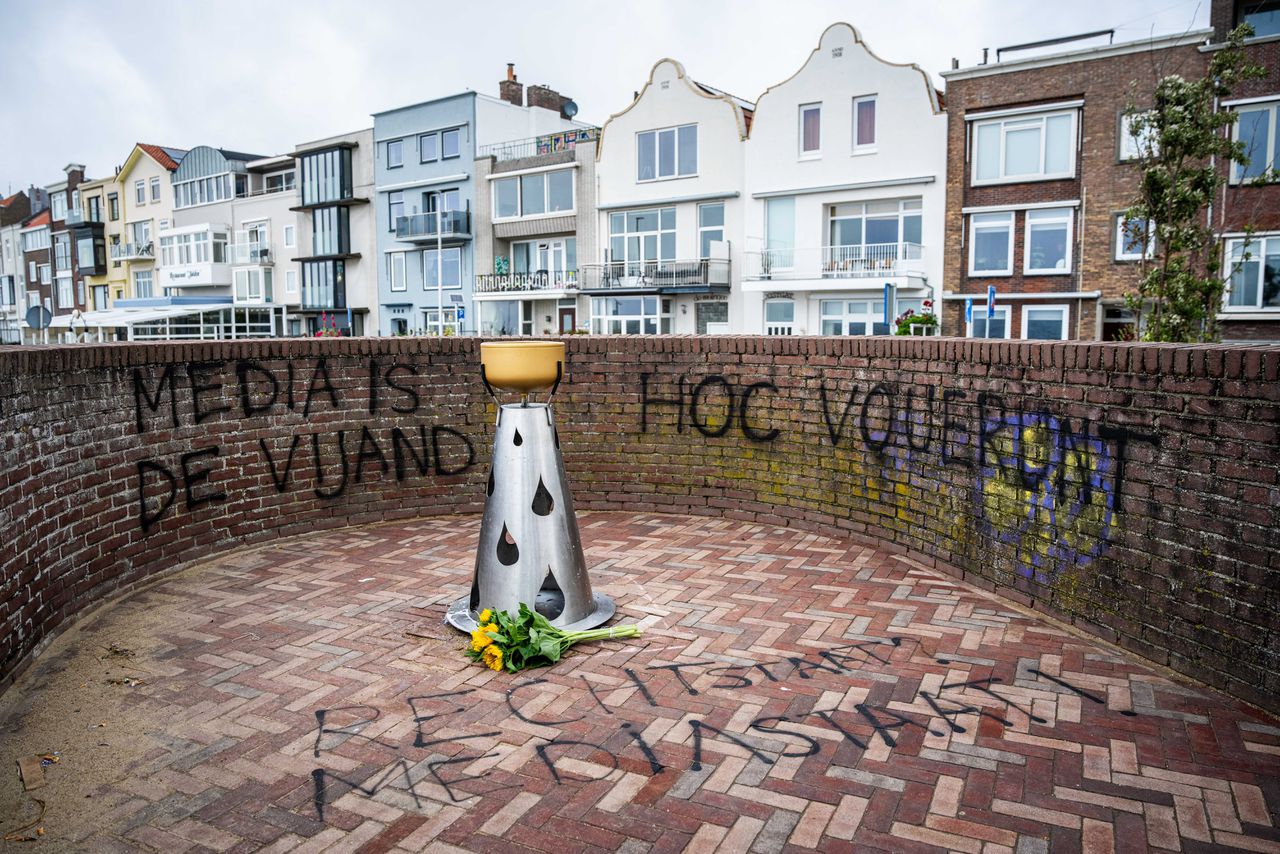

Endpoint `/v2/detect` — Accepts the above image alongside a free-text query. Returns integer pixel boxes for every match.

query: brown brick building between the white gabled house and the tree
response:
[942,29,1212,339]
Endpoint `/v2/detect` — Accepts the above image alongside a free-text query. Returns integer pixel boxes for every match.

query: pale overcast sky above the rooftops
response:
[0,0,1208,191]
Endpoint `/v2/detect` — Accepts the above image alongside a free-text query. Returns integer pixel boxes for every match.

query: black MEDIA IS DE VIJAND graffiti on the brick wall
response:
[133,357,476,531]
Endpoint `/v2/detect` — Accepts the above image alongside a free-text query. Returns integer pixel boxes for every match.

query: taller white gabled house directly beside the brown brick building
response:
[741,23,947,334]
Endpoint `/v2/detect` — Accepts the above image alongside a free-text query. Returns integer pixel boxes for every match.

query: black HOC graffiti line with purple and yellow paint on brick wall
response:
[640,374,1157,581]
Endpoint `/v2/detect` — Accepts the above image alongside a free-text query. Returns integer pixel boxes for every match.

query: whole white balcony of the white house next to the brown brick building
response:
[744,243,924,291]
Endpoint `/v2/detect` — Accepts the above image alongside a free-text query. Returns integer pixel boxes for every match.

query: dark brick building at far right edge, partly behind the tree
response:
[1201,0,1280,341]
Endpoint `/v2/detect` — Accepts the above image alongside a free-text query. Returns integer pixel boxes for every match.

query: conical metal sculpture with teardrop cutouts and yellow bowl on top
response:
[447,342,614,631]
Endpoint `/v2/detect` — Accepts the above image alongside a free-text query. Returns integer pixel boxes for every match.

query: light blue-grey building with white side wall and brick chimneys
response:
[374,68,585,335]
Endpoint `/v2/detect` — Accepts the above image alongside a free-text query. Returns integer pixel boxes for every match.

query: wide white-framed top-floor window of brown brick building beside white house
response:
[973,110,1075,184]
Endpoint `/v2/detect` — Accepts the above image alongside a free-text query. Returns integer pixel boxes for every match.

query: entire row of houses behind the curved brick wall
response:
[0,0,1280,341]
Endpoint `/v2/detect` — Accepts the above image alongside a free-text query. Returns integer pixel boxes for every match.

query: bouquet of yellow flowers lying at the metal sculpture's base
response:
[466,603,640,673]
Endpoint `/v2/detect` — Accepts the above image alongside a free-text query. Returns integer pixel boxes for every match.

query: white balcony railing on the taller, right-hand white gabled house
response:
[746,243,924,279]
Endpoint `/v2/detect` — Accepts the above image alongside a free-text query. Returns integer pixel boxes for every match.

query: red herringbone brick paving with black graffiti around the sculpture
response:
[6,513,1280,854]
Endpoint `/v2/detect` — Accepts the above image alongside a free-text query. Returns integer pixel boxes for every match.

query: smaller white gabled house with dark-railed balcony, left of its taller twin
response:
[580,59,753,334]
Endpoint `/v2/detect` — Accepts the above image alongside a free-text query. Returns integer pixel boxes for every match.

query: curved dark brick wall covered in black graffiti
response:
[0,337,1280,711]
